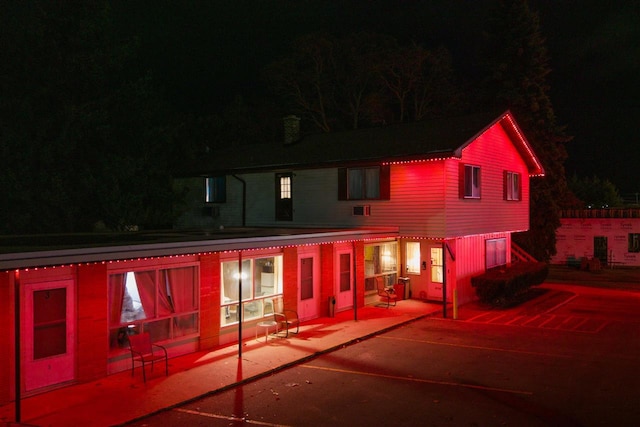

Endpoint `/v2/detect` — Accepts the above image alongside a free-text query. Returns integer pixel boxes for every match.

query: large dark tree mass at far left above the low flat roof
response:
[0,1,181,234]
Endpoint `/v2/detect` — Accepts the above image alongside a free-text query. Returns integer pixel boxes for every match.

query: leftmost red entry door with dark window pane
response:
[22,280,75,391]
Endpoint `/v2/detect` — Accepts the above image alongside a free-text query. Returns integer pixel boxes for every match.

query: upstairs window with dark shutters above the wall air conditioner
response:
[338,165,390,200]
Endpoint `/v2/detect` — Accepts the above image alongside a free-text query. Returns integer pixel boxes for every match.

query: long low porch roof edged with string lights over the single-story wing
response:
[0,227,398,270]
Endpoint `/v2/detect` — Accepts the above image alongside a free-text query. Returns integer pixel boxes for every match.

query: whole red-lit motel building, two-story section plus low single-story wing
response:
[0,112,544,404]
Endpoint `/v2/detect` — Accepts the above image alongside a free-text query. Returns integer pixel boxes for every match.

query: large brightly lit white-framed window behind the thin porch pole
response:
[220,255,282,326]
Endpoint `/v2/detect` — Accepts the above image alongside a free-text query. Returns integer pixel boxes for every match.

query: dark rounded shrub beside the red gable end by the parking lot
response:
[471,262,549,306]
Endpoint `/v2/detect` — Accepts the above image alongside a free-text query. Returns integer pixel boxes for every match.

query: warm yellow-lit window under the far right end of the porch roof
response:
[364,242,398,292]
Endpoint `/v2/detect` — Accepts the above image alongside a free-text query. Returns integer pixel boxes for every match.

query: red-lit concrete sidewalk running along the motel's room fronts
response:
[0,300,444,427]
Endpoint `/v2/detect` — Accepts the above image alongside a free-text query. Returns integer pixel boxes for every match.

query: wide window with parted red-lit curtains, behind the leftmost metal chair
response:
[108,266,199,350]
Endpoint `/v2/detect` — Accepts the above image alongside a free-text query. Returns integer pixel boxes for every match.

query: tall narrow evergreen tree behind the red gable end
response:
[481,0,569,261]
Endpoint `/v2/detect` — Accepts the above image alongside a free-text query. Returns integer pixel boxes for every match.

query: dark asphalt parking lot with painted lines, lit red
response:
[130,285,640,426]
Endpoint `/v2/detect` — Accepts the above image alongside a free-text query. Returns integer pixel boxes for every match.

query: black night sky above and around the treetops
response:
[115,0,640,195]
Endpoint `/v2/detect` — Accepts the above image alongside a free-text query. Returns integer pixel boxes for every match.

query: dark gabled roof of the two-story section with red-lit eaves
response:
[188,111,544,176]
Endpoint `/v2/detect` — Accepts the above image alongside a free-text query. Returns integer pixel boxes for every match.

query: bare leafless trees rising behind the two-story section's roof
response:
[265,32,462,132]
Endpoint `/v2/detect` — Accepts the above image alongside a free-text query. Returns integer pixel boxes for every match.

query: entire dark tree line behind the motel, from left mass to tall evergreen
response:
[0,0,569,260]
